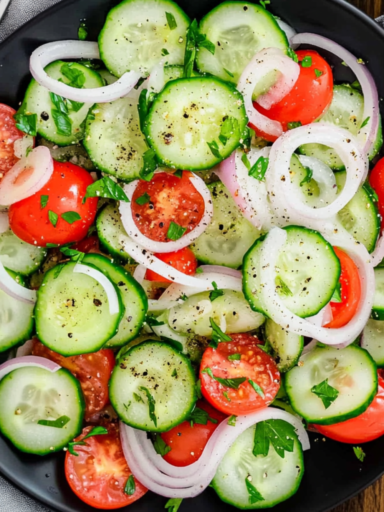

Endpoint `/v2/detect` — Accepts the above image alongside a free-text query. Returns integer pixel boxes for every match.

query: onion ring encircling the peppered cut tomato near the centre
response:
[119,175,213,253]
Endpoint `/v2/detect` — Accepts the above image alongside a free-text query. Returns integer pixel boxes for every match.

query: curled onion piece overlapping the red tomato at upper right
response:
[237,48,300,137]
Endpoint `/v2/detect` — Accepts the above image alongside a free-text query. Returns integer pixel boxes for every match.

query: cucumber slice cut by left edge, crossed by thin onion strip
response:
[0,269,34,353]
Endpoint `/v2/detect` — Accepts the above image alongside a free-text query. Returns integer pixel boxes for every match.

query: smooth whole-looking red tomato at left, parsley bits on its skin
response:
[9,162,97,247]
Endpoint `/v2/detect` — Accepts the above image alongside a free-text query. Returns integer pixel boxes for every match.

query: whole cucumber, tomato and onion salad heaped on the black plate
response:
[0,0,384,512]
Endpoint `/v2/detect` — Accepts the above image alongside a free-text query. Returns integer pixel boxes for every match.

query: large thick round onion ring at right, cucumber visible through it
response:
[266,123,368,225]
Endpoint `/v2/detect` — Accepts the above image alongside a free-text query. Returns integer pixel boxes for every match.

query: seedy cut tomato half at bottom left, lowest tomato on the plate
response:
[65,426,147,510]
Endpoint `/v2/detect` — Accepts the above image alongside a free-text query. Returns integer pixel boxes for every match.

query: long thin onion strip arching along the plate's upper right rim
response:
[291,33,380,154]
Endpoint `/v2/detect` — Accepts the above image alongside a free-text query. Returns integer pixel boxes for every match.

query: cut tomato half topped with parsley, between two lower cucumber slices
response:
[200,334,280,416]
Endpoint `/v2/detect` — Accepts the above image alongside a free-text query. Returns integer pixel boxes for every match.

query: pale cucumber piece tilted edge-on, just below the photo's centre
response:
[168,290,265,337]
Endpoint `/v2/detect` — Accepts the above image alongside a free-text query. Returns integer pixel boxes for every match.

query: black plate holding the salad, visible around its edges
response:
[0,0,384,512]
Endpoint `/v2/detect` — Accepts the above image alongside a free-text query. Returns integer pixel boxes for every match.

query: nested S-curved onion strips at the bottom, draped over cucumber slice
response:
[120,407,310,498]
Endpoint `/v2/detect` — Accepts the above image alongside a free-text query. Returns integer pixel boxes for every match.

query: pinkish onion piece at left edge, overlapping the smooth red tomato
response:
[0,146,53,205]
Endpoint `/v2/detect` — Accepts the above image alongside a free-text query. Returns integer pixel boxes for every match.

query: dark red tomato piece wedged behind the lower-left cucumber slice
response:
[32,340,115,421]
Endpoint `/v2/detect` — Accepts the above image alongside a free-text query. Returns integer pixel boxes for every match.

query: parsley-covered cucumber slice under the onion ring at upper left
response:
[22,60,104,146]
